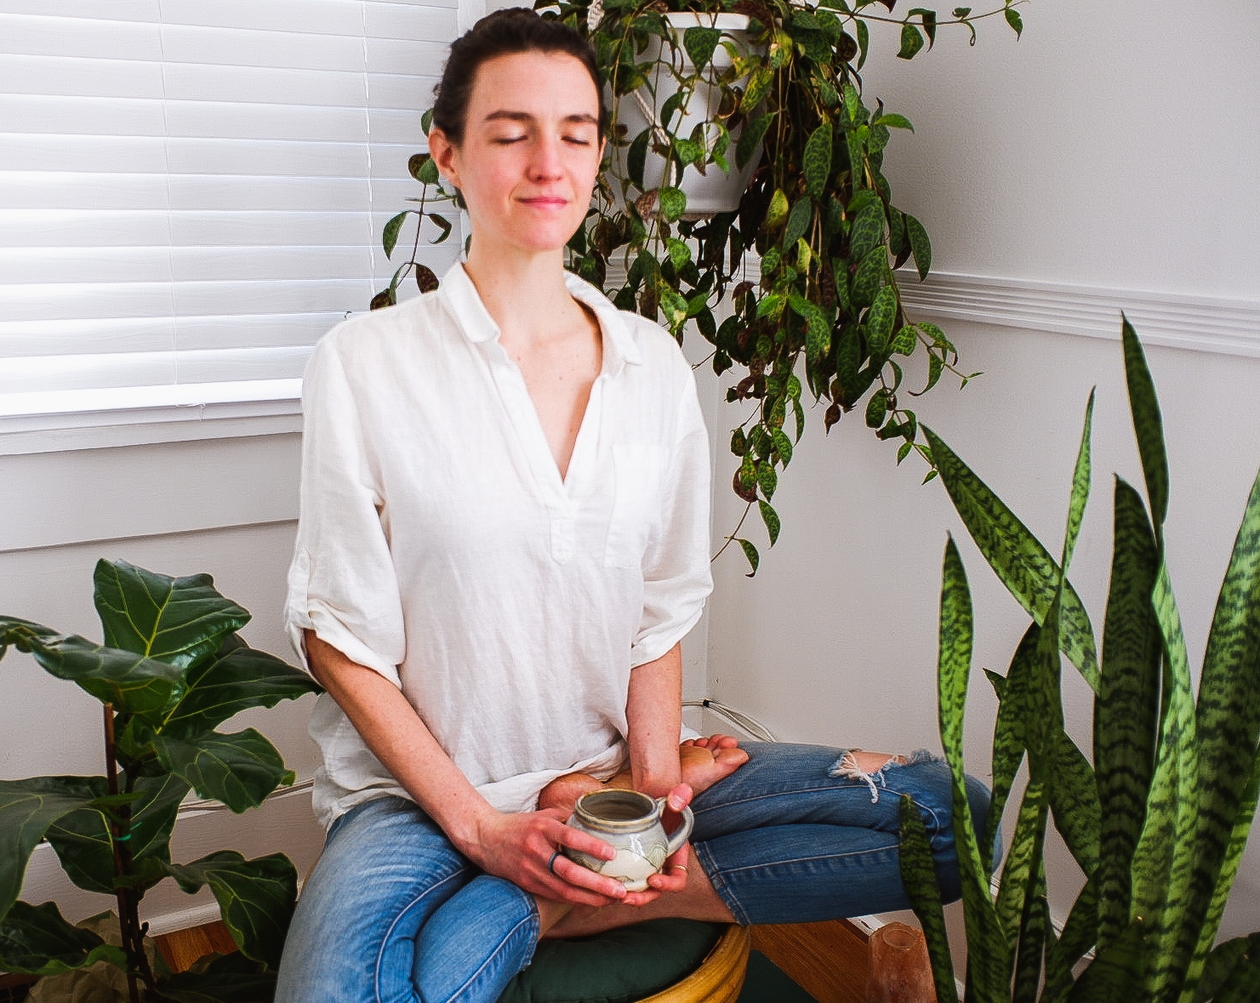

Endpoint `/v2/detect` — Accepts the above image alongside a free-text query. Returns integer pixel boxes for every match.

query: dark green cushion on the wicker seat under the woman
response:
[499,920,726,1003]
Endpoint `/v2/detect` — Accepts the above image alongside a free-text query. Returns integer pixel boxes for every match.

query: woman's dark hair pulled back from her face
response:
[433,8,609,145]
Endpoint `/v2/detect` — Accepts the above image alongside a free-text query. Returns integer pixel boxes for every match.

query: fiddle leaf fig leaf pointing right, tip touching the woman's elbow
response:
[163,635,320,738]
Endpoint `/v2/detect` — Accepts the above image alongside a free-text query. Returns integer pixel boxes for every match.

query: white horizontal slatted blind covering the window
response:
[0,0,459,425]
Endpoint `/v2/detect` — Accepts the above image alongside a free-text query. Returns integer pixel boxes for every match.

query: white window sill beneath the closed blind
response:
[0,379,302,456]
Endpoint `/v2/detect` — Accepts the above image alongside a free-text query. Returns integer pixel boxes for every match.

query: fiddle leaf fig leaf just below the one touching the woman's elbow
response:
[154,728,295,813]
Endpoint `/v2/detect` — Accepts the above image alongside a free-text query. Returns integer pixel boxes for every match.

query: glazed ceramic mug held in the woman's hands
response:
[564,790,696,892]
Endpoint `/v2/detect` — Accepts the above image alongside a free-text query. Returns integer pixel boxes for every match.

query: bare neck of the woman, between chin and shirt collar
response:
[464,238,577,338]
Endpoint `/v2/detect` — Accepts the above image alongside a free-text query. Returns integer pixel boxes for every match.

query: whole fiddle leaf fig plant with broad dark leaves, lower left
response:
[0,561,319,1003]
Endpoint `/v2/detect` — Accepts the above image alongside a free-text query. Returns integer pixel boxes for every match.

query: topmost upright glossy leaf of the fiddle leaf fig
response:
[92,561,249,668]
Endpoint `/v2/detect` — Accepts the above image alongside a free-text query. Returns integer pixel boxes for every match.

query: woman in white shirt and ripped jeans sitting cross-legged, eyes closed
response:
[277,10,987,1003]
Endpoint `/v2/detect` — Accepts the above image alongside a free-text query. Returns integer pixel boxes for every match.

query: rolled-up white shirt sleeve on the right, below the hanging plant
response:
[630,370,713,667]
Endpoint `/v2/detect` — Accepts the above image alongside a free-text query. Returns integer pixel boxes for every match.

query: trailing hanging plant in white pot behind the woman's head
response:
[372,0,1023,572]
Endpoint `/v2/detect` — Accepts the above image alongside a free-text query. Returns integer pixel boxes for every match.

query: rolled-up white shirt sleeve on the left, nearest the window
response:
[286,330,406,685]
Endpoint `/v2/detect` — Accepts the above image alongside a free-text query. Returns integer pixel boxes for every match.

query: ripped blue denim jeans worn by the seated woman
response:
[276,742,989,1003]
